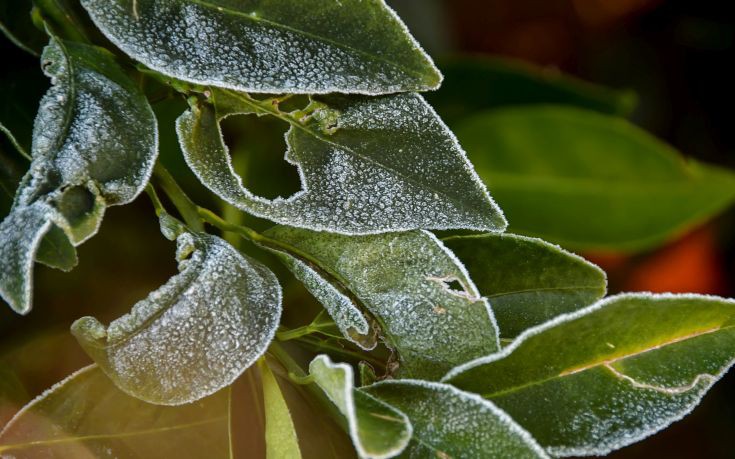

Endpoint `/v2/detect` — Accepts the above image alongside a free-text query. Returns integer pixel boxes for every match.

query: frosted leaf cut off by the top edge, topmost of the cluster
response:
[82,0,442,94]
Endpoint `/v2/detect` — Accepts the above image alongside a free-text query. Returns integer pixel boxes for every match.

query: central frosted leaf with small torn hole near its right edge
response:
[263,226,499,379]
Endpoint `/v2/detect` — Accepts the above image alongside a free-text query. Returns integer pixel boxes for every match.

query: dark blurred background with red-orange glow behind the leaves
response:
[0,0,735,458]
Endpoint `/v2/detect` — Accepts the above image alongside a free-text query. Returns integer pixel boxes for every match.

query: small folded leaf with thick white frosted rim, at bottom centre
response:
[309,355,412,459]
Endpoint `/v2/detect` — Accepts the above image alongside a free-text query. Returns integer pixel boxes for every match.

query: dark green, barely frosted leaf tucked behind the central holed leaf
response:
[443,234,607,338]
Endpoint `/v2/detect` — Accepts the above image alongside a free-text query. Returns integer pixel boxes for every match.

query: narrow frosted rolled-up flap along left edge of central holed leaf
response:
[277,252,377,351]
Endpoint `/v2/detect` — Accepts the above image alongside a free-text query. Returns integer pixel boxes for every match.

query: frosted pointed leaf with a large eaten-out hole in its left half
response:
[177,94,506,234]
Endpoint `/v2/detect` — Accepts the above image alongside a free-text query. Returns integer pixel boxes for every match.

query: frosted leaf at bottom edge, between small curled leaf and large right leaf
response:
[366,379,548,459]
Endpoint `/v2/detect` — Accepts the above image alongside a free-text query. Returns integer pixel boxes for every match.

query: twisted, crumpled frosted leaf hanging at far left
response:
[0,38,158,314]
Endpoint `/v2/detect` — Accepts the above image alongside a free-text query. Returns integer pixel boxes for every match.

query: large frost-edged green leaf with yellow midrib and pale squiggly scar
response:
[443,294,735,456]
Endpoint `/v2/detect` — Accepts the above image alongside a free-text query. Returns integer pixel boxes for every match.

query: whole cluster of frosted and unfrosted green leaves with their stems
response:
[0,0,735,458]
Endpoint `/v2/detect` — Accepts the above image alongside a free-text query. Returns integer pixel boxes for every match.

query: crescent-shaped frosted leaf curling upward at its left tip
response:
[72,233,281,405]
